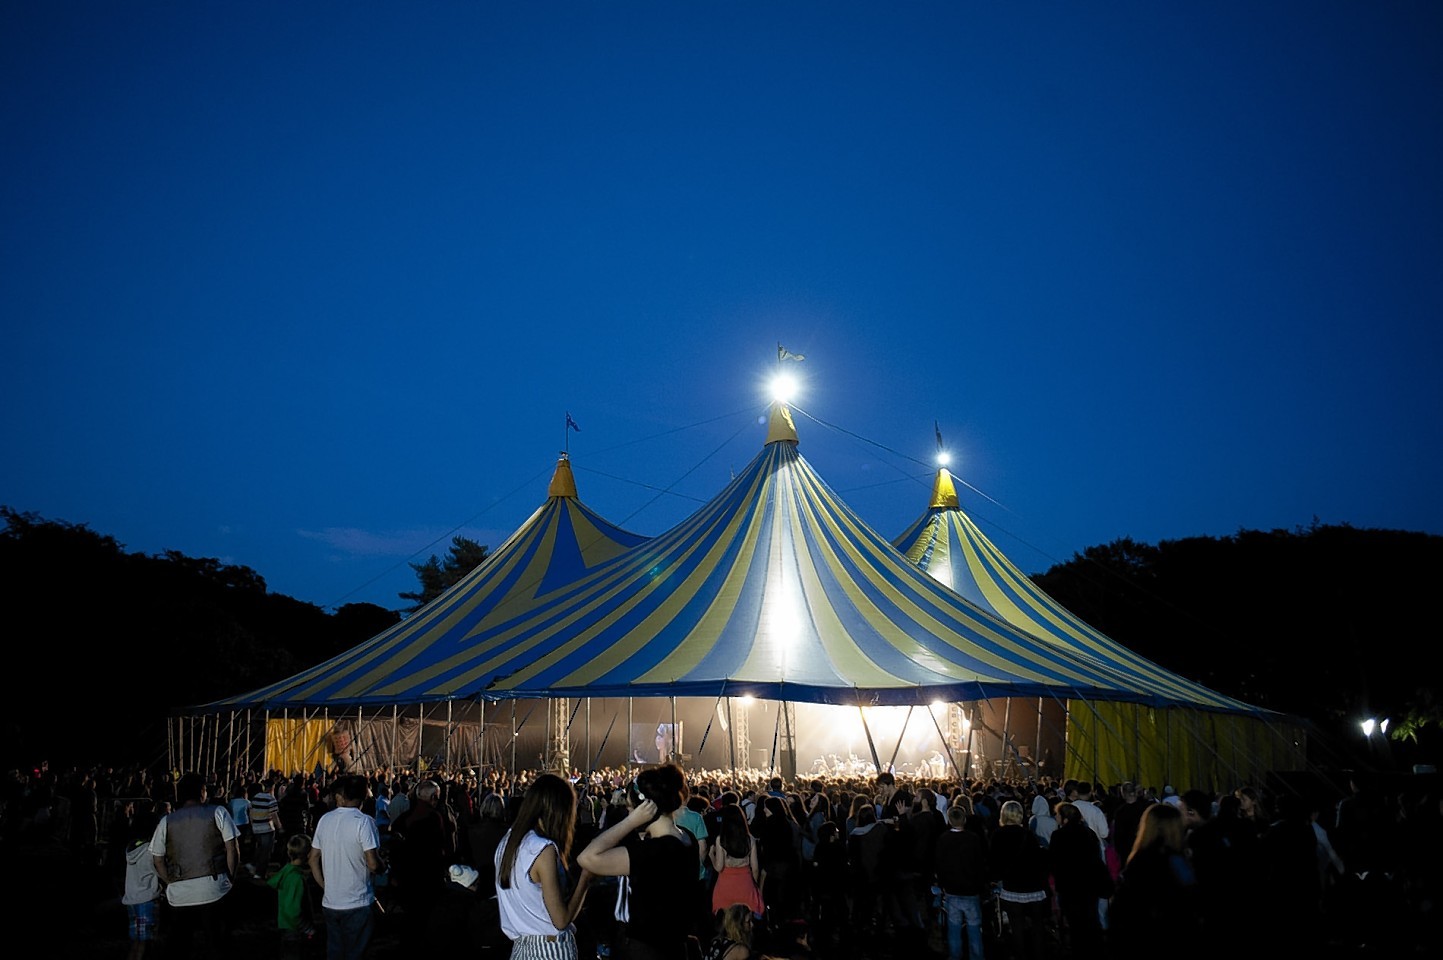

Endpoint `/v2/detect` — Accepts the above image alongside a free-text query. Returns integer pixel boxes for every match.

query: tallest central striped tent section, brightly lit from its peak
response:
[455,406,1223,706]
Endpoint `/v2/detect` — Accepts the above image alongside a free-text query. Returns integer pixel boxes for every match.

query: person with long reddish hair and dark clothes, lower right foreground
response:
[1107,803,1202,957]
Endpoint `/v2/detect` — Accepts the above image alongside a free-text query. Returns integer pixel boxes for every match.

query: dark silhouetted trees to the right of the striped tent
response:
[1033,521,1443,750]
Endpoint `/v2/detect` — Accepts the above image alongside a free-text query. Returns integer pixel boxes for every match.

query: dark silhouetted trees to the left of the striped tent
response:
[0,507,400,767]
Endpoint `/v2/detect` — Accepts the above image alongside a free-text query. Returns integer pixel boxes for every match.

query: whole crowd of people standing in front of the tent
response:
[0,764,1443,960]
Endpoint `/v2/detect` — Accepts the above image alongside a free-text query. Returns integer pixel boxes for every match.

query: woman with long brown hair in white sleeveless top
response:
[495,774,592,960]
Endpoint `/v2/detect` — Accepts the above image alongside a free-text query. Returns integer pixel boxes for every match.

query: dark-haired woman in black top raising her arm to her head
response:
[577,764,698,960]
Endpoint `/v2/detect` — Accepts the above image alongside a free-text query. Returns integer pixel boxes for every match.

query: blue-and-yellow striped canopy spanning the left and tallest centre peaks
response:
[211,406,1264,709]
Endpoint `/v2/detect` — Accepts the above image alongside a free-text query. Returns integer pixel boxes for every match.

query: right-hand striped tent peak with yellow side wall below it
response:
[892,468,1303,784]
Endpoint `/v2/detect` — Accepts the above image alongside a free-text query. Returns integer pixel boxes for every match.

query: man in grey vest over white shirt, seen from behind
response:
[150,774,241,957]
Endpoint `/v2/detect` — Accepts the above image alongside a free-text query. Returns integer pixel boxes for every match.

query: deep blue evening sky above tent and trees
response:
[0,0,1443,606]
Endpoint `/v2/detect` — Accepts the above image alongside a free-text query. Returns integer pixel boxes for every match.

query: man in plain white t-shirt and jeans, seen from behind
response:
[310,775,382,960]
